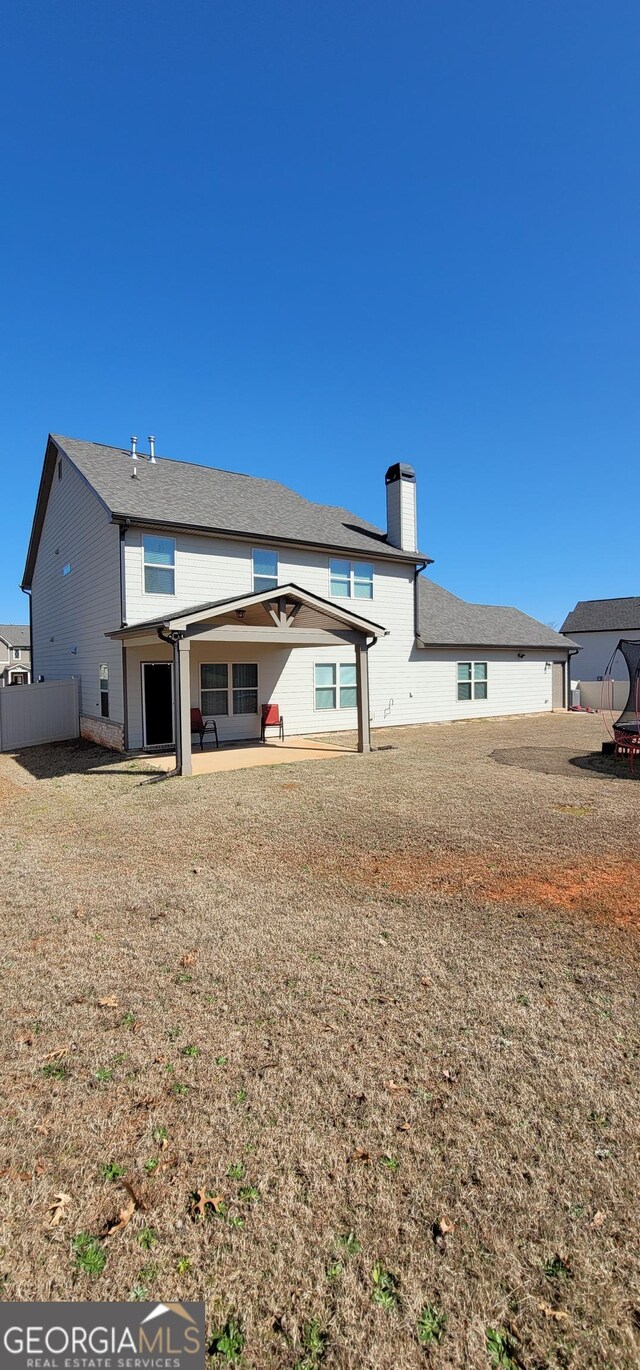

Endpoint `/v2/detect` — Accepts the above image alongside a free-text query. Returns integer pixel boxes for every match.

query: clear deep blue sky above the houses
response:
[0,0,640,622]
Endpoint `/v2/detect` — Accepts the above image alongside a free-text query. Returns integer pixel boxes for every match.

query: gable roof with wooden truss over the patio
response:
[106,584,388,645]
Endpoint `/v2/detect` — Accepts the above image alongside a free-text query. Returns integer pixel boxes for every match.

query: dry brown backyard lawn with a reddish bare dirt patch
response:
[0,715,640,1370]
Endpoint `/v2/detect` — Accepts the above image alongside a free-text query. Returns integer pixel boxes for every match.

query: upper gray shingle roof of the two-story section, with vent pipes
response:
[53,434,425,562]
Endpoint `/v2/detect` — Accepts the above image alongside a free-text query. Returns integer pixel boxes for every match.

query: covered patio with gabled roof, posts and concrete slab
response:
[108,584,386,775]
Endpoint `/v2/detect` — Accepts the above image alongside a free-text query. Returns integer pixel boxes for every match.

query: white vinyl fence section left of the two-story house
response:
[0,680,79,752]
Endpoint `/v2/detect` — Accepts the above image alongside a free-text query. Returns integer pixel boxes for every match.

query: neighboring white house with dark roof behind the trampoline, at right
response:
[561,595,640,681]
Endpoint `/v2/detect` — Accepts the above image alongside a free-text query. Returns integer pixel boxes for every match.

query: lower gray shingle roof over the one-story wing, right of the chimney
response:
[418,575,574,651]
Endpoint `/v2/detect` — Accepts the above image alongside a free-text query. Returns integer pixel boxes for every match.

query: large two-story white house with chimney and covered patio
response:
[23,437,574,771]
